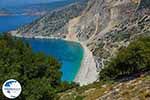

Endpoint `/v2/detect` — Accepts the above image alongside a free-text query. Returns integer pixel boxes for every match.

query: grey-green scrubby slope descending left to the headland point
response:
[15,2,85,37]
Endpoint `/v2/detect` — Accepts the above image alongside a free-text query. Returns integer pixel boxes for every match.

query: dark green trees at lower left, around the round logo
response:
[0,36,77,100]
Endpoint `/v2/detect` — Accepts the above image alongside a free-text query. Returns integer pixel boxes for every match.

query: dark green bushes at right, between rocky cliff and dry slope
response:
[99,37,150,80]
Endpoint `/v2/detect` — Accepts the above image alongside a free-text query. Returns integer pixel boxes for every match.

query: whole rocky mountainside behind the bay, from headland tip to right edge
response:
[13,0,150,84]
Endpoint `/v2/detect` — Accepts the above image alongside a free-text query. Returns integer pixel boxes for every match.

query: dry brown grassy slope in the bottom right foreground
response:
[55,72,150,100]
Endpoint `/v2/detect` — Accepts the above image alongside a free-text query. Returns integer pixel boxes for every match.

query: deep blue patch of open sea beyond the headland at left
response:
[0,15,38,32]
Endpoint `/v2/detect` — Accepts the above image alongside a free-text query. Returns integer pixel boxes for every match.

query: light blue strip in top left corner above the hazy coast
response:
[0,0,63,7]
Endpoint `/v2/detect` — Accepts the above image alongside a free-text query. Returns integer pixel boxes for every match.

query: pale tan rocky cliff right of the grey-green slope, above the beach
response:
[67,0,150,68]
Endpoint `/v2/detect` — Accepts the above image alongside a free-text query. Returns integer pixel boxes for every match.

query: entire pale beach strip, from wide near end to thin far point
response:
[10,31,98,86]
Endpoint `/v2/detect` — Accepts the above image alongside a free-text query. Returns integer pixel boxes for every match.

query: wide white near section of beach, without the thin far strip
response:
[74,42,98,86]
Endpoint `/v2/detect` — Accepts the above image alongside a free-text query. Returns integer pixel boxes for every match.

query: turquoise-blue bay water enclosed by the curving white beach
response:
[25,39,83,81]
